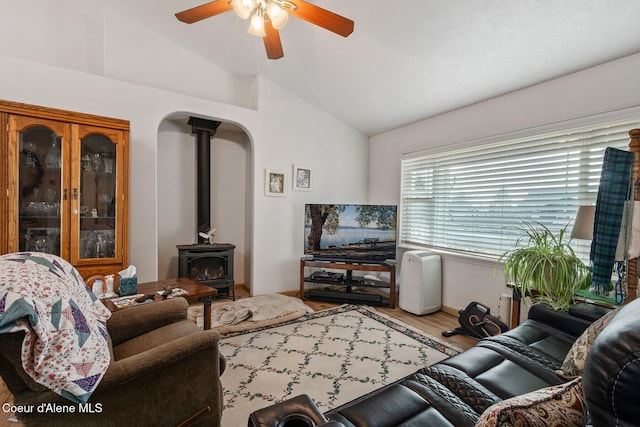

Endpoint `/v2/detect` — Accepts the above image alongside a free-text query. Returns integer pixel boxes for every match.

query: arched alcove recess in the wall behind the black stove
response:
[156,113,253,290]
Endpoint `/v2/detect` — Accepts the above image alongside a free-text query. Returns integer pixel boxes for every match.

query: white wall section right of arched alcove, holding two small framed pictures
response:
[252,78,368,293]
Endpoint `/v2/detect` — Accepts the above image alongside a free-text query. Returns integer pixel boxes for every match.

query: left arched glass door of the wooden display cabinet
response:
[9,116,68,256]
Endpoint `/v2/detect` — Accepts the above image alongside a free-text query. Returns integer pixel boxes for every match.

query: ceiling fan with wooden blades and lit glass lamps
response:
[176,0,354,59]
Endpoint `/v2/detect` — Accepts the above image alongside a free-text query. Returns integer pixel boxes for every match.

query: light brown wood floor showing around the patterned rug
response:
[0,286,477,427]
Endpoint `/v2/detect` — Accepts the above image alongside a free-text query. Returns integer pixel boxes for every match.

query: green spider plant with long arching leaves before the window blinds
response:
[498,222,591,310]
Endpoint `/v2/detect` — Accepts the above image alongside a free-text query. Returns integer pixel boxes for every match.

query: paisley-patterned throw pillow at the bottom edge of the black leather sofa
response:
[476,377,587,427]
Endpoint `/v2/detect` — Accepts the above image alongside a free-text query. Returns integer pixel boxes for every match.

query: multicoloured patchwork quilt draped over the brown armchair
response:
[0,252,111,403]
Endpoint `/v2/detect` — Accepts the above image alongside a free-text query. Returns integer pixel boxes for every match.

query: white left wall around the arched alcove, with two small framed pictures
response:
[0,0,368,294]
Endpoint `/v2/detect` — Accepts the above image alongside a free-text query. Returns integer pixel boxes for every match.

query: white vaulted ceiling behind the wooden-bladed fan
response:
[104,0,640,135]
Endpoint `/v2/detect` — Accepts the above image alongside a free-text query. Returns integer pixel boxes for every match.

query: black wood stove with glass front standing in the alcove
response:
[177,243,236,301]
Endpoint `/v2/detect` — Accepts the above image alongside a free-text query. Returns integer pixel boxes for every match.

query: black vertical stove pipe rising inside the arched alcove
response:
[188,117,220,243]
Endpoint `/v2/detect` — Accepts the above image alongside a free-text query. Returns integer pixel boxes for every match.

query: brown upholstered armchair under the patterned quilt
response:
[0,298,225,426]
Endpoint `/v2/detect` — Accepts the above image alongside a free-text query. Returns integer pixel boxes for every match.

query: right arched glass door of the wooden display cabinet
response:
[72,126,122,263]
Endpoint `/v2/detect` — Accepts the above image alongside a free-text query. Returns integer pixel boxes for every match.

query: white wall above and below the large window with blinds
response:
[369,54,640,320]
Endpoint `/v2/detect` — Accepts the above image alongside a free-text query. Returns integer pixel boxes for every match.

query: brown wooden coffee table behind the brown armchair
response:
[102,277,218,329]
